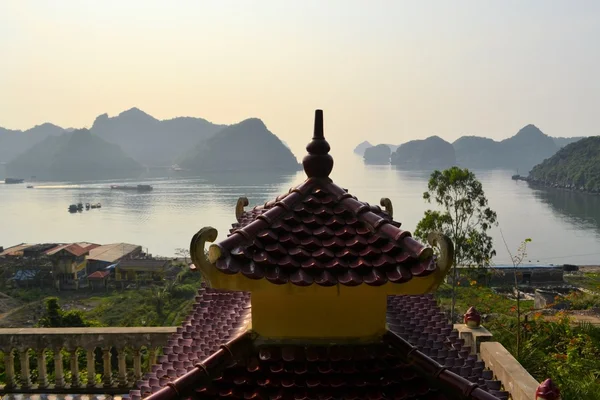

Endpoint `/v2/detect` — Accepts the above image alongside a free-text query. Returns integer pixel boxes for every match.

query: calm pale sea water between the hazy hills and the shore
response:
[0,158,600,265]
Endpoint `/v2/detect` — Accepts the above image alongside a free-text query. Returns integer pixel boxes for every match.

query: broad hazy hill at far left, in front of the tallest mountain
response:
[7,129,142,181]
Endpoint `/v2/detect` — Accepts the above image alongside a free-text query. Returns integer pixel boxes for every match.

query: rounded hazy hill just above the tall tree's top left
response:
[391,136,456,170]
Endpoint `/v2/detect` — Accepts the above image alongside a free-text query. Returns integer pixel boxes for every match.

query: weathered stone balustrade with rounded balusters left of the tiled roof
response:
[0,327,177,394]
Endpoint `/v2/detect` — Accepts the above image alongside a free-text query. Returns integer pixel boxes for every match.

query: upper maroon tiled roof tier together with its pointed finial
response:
[209,110,437,286]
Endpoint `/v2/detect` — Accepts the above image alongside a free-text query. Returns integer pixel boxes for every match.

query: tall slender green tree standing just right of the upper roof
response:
[414,167,497,320]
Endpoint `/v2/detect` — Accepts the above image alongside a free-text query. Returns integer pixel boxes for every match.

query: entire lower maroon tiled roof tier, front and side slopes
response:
[131,288,508,400]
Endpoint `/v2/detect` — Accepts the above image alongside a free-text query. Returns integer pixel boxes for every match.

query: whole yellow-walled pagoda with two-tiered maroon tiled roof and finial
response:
[130,111,557,400]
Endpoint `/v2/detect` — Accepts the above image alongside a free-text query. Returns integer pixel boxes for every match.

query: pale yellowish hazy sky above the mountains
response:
[0,0,600,156]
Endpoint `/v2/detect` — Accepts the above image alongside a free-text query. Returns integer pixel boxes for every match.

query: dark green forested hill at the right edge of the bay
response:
[529,136,600,192]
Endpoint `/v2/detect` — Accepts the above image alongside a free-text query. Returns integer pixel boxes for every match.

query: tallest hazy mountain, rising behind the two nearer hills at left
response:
[91,107,224,166]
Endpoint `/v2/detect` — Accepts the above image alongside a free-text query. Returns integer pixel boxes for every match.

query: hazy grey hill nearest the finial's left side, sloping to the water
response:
[180,118,300,172]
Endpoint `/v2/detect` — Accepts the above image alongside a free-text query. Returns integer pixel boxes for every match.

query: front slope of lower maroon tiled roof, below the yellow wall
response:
[146,332,498,400]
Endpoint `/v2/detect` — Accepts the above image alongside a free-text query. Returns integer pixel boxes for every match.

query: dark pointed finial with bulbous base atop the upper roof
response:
[302,110,333,178]
